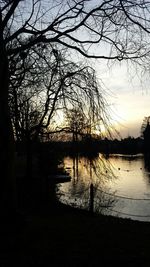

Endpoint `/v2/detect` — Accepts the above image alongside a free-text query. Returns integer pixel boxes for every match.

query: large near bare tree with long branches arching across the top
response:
[0,0,150,216]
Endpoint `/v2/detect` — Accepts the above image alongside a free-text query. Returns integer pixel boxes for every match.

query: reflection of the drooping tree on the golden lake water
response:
[59,155,116,216]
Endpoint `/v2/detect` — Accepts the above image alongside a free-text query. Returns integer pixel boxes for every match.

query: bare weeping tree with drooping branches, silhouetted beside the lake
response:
[9,45,109,141]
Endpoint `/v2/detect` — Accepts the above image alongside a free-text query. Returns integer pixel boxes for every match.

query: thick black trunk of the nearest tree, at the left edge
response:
[0,27,16,216]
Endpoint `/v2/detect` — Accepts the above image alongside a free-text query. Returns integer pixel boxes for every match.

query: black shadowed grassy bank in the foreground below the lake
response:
[0,205,150,267]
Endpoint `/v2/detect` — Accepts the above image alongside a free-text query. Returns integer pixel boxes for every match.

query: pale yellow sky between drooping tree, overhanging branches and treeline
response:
[97,63,150,137]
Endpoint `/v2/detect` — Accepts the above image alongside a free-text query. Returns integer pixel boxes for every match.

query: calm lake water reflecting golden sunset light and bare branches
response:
[58,154,150,221]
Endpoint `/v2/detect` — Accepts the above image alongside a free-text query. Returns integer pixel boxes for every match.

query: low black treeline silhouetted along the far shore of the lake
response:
[16,137,144,161]
